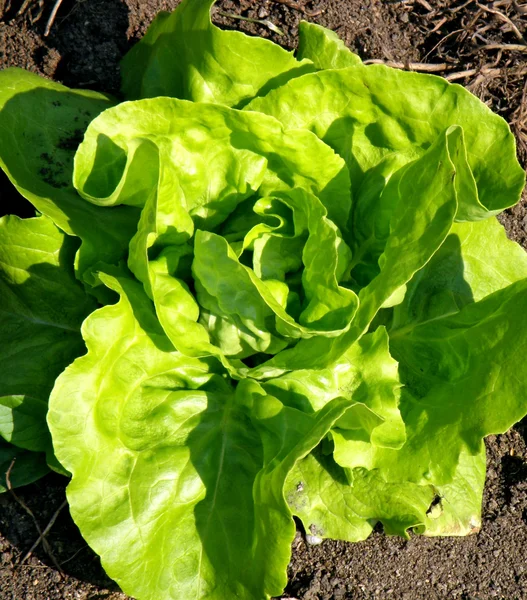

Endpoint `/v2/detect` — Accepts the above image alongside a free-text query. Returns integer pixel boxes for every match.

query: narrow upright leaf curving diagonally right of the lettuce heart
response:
[250,127,462,378]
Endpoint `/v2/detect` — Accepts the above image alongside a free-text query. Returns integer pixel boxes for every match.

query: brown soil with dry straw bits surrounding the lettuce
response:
[0,0,527,600]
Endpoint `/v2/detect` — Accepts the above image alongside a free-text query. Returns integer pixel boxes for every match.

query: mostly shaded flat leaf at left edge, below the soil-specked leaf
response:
[0,216,96,451]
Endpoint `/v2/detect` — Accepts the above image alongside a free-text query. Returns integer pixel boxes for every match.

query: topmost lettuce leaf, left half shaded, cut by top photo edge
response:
[121,0,313,106]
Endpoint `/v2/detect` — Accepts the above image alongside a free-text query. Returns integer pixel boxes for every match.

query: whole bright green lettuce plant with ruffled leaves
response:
[0,0,527,600]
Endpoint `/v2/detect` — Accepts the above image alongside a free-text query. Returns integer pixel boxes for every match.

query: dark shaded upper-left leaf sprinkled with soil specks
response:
[0,68,138,275]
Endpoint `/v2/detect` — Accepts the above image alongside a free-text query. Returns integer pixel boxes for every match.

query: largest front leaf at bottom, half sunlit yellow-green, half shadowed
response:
[49,275,358,600]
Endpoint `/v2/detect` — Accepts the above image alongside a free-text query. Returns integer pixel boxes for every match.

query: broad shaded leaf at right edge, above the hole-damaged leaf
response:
[376,279,527,485]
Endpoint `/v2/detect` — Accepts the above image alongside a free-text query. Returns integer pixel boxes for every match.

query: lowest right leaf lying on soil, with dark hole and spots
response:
[285,446,485,542]
